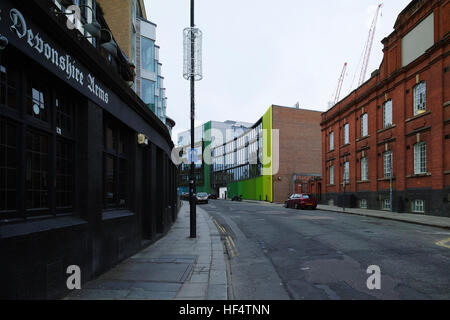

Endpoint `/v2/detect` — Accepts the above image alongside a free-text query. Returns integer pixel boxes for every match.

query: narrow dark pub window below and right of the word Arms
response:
[104,120,129,209]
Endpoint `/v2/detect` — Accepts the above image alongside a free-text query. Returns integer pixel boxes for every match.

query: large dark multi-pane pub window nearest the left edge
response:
[0,55,78,220]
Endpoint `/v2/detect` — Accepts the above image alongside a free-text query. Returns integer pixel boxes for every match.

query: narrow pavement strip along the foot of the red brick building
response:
[317,204,450,229]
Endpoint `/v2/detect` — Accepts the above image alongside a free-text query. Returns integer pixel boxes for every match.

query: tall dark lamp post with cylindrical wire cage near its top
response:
[183,0,203,238]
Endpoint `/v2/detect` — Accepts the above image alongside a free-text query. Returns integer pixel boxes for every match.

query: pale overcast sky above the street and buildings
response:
[145,0,410,141]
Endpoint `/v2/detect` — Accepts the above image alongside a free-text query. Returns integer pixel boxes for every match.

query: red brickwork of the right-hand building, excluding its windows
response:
[322,0,450,216]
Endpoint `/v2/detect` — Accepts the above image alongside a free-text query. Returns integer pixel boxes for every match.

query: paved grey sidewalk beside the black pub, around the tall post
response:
[65,202,228,300]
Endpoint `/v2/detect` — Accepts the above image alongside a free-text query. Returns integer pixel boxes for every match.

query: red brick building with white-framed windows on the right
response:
[321,0,450,216]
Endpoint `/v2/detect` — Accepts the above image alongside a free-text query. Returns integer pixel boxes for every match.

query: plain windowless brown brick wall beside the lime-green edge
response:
[272,106,322,202]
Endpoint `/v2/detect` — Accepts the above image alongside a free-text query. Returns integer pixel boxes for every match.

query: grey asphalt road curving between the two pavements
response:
[201,200,450,300]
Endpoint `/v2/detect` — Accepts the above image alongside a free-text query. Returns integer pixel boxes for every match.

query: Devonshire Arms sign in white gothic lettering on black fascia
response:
[0,0,112,105]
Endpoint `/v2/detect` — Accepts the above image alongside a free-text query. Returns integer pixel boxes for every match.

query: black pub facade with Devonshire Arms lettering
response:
[0,0,179,299]
